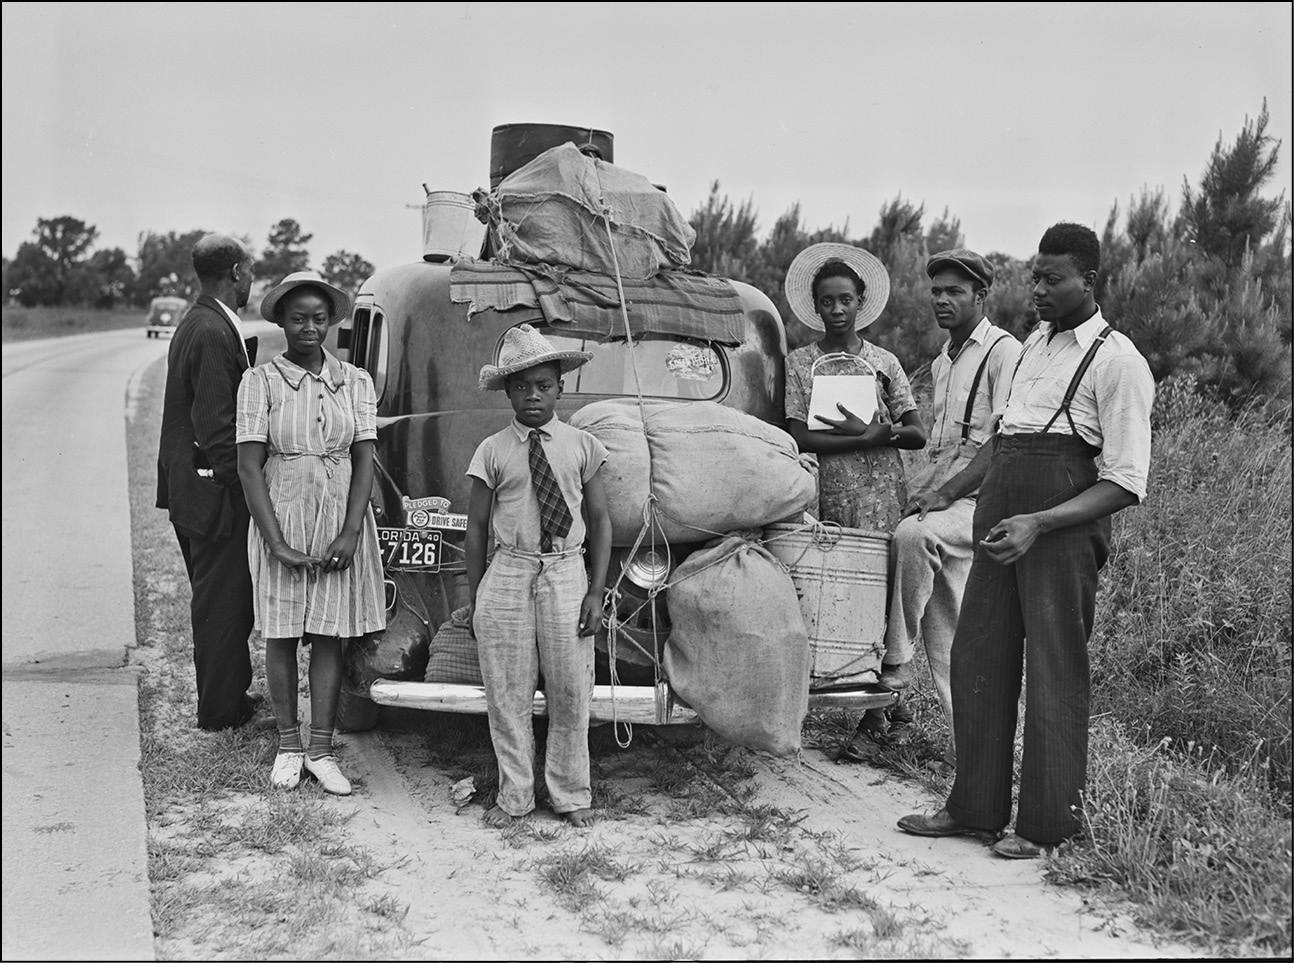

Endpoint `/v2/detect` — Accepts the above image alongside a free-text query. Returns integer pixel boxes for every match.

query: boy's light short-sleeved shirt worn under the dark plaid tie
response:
[467,415,607,553]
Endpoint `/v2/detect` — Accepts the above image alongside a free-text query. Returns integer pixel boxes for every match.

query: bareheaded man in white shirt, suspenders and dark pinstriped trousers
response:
[898,224,1154,859]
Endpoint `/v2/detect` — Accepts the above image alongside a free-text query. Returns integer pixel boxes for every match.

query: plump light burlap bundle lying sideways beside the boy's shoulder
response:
[571,399,818,545]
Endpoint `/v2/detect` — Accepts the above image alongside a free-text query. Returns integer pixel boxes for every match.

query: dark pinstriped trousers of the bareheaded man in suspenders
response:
[947,435,1110,845]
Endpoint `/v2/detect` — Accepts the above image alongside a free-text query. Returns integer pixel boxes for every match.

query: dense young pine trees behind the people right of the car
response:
[690,102,1290,406]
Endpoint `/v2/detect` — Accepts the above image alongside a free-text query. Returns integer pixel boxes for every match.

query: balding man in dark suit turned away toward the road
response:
[157,234,259,730]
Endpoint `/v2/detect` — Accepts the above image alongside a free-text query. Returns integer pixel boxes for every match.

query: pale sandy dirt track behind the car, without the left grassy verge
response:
[307,716,1190,959]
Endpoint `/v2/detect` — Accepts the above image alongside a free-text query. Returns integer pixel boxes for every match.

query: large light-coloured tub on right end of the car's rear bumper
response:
[763,523,890,689]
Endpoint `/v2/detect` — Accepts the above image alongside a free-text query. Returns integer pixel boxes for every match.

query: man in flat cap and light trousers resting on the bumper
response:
[885,247,1020,766]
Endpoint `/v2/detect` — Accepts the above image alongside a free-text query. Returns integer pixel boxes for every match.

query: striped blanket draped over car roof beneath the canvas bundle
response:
[449,259,745,344]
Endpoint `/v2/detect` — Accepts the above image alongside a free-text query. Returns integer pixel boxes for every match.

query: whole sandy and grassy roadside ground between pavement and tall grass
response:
[123,346,1192,960]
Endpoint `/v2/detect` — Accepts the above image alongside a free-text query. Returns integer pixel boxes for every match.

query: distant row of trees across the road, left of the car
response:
[3,215,374,308]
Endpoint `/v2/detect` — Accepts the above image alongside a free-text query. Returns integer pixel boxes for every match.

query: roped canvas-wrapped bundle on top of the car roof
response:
[484,144,696,280]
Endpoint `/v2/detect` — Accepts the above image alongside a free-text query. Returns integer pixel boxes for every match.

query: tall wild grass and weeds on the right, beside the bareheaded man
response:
[1051,379,1291,957]
